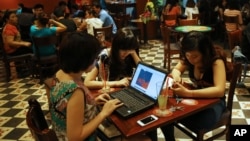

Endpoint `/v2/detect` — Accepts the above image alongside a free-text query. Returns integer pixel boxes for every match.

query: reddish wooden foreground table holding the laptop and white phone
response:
[110,98,220,137]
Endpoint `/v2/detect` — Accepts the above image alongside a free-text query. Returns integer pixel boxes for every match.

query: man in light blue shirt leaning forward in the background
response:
[93,1,117,34]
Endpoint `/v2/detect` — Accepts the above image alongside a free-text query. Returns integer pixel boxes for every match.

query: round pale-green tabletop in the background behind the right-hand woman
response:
[174,25,212,33]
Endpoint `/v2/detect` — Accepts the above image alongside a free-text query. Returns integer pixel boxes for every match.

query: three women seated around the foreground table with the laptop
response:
[42,28,227,141]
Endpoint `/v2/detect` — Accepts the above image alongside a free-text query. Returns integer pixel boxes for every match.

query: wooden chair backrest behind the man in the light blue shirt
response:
[93,25,113,42]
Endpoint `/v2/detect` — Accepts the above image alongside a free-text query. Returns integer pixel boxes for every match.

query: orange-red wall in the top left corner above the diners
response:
[0,0,60,14]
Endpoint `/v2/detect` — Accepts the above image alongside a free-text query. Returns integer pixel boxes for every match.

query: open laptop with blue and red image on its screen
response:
[110,62,168,118]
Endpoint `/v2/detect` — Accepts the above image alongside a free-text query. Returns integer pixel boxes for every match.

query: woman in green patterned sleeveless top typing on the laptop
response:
[49,32,122,141]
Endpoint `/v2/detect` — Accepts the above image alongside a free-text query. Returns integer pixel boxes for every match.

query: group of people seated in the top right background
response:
[161,0,250,40]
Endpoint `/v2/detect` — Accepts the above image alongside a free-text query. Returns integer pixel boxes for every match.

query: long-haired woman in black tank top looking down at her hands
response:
[161,31,228,141]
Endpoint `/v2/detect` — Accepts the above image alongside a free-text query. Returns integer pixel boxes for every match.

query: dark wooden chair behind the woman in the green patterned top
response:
[26,99,58,141]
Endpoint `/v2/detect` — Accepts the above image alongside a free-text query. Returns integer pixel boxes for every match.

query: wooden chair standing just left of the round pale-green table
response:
[160,25,180,71]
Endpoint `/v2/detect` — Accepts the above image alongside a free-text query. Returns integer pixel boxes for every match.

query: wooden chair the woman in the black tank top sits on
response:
[175,63,241,141]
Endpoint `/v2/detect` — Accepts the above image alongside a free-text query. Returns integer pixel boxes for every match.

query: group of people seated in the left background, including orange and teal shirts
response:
[1,1,117,76]
